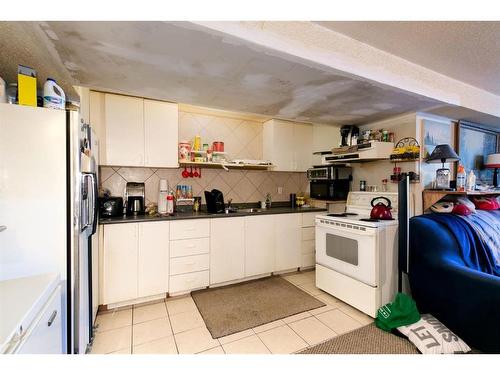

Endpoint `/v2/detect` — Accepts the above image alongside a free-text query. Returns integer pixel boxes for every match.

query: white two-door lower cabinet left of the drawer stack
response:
[102,222,169,304]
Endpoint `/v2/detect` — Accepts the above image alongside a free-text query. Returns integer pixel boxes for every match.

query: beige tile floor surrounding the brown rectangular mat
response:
[91,271,373,354]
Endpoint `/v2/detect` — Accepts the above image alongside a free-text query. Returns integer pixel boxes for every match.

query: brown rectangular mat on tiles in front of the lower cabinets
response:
[191,276,325,339]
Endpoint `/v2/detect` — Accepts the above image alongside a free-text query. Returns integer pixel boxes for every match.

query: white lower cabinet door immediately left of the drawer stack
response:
[137,221,170,298]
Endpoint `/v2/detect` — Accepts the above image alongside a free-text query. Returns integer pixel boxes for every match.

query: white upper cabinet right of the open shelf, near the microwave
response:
[263,119,313,172]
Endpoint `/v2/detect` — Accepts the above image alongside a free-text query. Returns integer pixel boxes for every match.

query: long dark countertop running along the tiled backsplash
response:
[99,207,326,224]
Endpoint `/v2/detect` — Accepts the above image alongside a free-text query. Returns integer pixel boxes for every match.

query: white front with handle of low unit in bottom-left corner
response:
[17,286,62,354]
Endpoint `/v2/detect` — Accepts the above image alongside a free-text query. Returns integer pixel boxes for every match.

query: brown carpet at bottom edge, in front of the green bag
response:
[299,323,420,354]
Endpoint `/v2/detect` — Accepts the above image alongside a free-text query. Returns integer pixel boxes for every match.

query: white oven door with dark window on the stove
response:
[316,219,379,287]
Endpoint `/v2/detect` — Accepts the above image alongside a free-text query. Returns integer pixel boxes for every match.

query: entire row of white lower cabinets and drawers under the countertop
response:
[100,213,317,305]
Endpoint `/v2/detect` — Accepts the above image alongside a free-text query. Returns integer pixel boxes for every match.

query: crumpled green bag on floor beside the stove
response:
[375,293,420,332]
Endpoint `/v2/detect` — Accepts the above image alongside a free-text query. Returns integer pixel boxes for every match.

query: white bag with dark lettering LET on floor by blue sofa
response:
[398,314,471,354]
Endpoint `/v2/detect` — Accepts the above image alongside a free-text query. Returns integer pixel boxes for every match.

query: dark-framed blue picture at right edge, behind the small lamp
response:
[458,121,500,184]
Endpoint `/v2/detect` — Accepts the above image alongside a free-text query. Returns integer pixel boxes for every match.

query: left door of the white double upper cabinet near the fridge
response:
[104,94,144,167]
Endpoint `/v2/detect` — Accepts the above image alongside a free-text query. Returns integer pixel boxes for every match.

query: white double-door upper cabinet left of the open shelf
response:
[90,91,178,167]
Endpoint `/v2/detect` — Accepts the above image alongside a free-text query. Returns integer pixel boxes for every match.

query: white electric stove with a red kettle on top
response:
[316,191,398,317]
